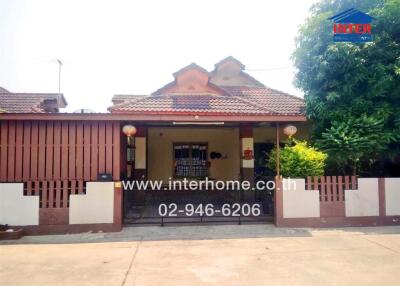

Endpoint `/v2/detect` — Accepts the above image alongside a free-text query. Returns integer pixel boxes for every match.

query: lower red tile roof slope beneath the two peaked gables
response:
[109,87,304,115]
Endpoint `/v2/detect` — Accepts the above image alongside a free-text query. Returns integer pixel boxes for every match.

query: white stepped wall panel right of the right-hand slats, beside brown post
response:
[345,178,379,217]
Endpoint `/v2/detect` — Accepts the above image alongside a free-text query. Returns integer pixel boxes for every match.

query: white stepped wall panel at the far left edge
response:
[0,183,39,226]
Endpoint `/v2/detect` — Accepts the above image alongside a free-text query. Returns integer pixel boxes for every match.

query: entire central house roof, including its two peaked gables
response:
[108,57,305,116]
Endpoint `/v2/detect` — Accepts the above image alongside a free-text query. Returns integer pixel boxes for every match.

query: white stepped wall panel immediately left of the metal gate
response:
[69,182,114,224]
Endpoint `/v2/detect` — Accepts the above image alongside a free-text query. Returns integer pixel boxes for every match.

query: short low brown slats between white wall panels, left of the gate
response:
[24,180,86,209]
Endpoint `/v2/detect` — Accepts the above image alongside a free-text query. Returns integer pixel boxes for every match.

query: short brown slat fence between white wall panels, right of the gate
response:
[306,176,357,202]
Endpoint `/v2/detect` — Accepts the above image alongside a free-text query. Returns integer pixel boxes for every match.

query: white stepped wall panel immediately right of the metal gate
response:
[282,179,320,218]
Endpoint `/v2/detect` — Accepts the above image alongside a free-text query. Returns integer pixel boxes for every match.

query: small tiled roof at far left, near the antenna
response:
[0,92,67,113]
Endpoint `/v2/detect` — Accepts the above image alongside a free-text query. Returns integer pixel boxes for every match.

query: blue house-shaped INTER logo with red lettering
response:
[329,8,375,43]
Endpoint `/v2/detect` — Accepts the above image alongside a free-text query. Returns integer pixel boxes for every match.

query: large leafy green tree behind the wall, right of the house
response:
[293,0,400,174]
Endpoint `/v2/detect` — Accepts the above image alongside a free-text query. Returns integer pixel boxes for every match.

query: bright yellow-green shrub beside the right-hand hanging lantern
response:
[267,140,328,178]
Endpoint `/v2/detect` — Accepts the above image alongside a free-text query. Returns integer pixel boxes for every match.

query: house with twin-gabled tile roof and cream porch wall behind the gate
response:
[108,57,307,184]
